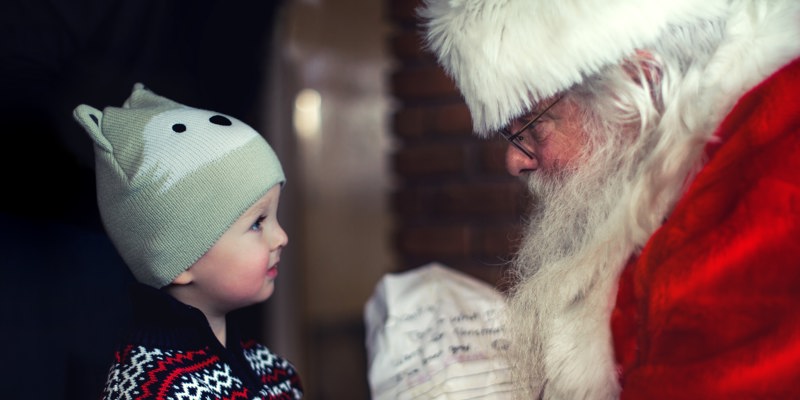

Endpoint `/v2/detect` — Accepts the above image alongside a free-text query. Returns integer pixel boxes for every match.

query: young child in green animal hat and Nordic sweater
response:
[74,83,303,399]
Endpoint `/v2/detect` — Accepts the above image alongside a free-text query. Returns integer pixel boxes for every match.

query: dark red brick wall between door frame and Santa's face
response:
[387,0,530,287]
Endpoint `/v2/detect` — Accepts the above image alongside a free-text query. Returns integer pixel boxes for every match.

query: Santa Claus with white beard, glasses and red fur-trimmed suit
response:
[418,0,800,399]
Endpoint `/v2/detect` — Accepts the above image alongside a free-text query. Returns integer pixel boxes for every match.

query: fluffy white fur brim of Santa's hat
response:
[417,0,728,136]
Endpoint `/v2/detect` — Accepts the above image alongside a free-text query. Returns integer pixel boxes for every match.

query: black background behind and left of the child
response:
[0,0,282,399]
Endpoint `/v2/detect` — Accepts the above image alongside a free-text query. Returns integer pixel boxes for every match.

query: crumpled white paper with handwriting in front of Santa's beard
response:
[364,263,517,400]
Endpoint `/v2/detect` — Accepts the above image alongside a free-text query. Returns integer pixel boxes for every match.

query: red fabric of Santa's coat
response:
[612,59,800,399]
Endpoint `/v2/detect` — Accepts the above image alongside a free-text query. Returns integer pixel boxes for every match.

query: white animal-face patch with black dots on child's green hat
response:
[138,107,258,192]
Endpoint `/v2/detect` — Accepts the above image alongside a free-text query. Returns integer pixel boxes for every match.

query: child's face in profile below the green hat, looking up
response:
[179,185,288,314]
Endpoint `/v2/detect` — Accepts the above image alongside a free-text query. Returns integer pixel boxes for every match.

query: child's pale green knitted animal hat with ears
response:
[73,83,285,288]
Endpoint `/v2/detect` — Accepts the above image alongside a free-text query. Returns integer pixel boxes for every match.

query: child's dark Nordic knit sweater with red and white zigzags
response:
[102,284,303,400]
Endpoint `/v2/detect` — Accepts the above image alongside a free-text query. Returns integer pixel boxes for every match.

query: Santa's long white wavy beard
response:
[507,130,640,399]
